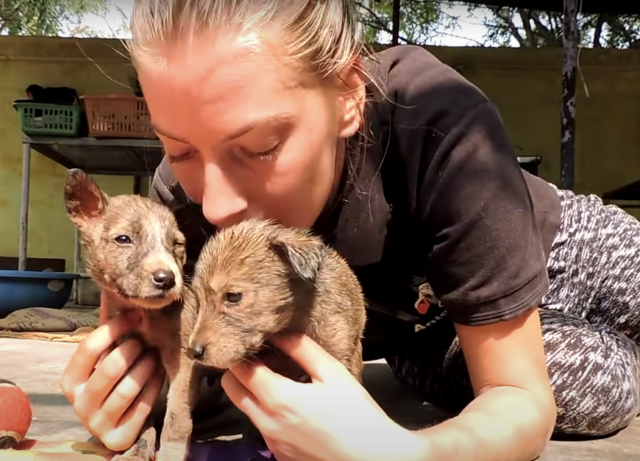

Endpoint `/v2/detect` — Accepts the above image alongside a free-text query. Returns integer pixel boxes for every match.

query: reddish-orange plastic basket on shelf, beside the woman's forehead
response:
[80,94,157,139]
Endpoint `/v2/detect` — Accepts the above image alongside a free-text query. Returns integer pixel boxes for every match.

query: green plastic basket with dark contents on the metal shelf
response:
[13,101,82,137]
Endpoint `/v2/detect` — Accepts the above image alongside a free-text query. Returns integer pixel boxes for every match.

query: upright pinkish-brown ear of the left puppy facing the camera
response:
[64,168,108,226]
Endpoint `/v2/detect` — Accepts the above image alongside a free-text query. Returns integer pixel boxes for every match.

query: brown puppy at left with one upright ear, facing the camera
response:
[64,169,201,461]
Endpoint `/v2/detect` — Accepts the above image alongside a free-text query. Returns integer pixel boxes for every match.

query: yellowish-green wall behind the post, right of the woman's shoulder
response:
[424,48,640,195]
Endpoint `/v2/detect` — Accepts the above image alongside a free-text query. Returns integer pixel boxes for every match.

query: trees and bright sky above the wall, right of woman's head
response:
[356,0,640,48]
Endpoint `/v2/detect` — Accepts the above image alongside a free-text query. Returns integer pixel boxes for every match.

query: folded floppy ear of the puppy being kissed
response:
[271,235,327,281]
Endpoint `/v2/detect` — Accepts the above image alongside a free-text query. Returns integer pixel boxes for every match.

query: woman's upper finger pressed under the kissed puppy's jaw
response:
[272,334,348,382]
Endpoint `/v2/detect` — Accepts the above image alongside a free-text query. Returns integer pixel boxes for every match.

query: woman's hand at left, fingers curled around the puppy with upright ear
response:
[60,292,164,451]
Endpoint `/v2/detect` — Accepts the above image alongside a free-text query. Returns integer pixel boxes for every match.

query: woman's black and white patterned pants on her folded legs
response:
[387,186,640,436]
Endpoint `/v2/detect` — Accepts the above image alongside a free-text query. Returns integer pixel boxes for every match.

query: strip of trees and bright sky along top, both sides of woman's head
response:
[0,0,640,48]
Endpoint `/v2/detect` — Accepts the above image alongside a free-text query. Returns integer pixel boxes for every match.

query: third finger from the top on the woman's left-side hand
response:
[102,353,158,422]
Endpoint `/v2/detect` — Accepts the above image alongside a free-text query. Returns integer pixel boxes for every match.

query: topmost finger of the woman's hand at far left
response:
[60,319,137,398]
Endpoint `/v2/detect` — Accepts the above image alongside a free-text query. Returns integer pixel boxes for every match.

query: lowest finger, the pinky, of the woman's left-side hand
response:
[100,367,165,451]
